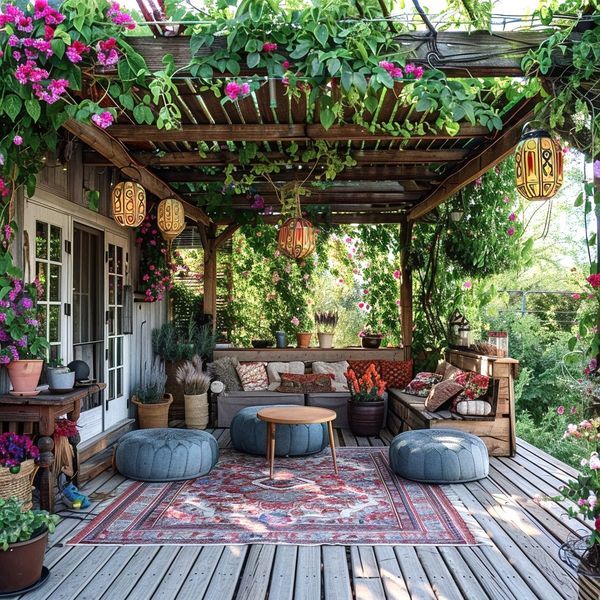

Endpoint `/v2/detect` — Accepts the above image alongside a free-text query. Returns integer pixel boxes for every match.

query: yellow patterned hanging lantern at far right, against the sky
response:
[515,125,563,200]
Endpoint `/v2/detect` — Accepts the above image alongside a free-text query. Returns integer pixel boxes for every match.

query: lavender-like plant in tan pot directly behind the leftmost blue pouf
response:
[131,357,173,429]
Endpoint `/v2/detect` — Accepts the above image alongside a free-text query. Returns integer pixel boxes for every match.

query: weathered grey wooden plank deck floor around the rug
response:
[16,430,589,600]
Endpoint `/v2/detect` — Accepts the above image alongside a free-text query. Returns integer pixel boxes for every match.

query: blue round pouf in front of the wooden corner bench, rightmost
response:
[390,429,490,483]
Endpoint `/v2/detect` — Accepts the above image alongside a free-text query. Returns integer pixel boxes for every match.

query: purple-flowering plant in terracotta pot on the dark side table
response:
[0,274,49,396]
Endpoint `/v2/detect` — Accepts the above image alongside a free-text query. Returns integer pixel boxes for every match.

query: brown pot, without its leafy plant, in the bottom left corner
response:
[0,529,48,594]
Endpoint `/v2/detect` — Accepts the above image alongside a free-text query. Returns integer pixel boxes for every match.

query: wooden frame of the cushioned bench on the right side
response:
[388,350,519,456]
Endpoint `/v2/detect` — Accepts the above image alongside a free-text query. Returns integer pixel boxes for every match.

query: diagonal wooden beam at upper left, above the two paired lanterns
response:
[63,119,210,224]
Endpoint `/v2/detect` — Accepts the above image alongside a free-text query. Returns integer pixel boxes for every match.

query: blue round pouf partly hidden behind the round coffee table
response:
[229,404,329,456]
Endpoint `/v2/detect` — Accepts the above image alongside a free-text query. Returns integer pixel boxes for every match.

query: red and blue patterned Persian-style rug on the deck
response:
[69,447,486,545]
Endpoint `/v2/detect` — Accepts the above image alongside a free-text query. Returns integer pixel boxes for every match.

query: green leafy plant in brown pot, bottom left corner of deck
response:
[0,498,60,594]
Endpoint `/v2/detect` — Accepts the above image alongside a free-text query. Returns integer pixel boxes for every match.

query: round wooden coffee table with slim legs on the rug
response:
[256,406,338,479]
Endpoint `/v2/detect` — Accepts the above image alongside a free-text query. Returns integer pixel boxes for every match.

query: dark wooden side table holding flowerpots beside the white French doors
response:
[0,383,106,512]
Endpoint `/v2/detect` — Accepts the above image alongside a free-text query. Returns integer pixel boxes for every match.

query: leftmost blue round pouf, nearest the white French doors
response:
[115,429,219,481]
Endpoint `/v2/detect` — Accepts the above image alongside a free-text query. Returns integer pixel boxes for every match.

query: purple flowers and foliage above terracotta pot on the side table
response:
[0,270,48,365]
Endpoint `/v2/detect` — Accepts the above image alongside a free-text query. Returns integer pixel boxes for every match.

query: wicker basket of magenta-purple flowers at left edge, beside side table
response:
[0,432,40,510]
